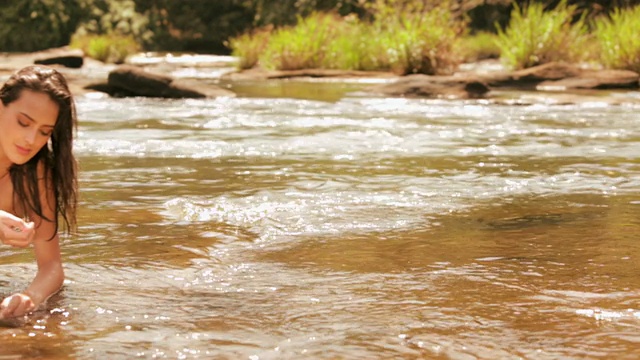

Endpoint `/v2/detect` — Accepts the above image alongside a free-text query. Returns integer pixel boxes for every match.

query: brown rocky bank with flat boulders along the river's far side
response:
[0,48,640,104]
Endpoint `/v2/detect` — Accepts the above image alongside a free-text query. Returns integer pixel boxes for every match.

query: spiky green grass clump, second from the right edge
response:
[497,0,588,69]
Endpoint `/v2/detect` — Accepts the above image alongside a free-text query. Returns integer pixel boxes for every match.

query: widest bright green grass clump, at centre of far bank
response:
[229,0,465,74]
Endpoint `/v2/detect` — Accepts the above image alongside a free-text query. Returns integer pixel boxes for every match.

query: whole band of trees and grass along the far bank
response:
[0,0,640,74]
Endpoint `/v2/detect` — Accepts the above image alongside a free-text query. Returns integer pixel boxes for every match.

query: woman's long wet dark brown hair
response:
[0,66,78,238]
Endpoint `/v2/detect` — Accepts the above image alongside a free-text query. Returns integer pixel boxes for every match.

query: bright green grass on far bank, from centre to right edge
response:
[229,0,640,74]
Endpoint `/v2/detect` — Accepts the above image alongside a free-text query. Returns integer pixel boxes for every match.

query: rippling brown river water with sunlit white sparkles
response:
[0,67,640,360]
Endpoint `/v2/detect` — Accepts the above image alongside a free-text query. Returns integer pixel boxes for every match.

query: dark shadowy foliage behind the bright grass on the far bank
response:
[0,0,510,54]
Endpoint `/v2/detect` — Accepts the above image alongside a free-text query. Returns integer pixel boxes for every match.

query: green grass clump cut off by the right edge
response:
[593,5,640,72]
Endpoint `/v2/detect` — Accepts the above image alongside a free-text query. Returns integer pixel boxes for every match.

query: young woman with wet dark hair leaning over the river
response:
[0,66,78,318]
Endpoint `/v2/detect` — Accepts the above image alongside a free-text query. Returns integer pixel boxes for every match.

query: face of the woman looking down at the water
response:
[0,90,59,165]
